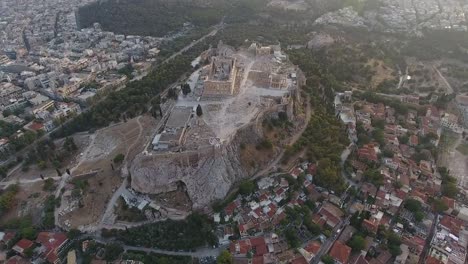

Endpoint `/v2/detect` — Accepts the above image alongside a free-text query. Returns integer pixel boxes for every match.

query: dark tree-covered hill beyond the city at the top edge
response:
[77,0,228,36]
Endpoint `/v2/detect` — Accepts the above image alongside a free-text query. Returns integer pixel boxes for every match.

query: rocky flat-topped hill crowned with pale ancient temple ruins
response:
[130,43,305,209]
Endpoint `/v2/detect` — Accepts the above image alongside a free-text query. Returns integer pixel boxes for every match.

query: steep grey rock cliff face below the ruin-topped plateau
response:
[130,123,262,210]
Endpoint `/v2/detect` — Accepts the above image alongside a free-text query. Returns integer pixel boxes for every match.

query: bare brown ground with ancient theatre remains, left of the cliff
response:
[59,116,156,227]
